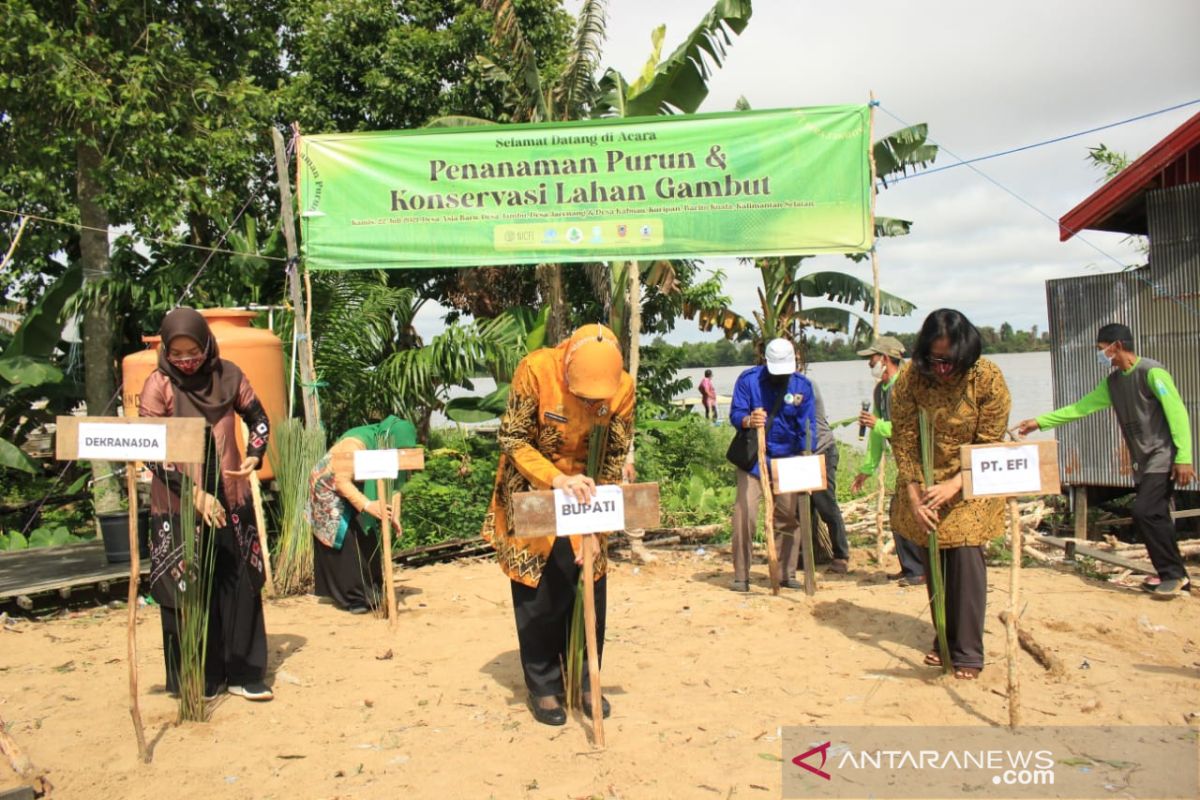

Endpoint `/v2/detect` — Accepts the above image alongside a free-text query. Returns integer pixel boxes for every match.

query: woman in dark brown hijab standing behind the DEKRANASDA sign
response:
[138,308,272,700]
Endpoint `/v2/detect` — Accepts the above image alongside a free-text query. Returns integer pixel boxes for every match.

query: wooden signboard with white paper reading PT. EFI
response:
[961,440,1060,500]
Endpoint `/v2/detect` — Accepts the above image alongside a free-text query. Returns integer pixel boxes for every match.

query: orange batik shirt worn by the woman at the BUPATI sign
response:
[482,342,634,588]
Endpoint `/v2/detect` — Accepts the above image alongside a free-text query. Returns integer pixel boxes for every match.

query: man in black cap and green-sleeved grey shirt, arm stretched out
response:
[1016,323,1195,599]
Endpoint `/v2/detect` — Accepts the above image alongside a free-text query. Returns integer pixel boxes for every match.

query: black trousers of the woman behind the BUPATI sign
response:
[512,536,608,697]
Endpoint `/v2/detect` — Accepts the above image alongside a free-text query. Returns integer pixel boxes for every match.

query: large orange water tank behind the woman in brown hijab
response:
[121,308,288,480]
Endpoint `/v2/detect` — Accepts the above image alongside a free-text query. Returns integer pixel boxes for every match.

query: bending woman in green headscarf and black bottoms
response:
[308,416,416,614]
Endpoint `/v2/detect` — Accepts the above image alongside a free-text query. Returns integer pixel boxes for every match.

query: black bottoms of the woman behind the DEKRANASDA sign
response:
[161,529,266,692]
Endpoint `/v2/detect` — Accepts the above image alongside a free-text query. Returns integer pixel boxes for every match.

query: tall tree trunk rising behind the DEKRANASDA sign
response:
[76,133,121,513]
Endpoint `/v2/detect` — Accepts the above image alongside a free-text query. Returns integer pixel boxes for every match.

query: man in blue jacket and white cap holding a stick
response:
[730,339,817,591]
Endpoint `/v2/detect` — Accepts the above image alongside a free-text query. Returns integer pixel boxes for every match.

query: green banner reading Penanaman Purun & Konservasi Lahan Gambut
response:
[300,106,874,270]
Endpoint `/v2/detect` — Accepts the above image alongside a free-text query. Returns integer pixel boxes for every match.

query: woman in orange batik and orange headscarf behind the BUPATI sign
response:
[482,325,635,724]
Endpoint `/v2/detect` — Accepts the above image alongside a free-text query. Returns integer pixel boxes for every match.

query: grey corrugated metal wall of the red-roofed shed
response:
[1046,184,1200,488]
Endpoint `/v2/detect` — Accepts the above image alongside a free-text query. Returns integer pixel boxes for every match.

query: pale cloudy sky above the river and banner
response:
[422,0,1200,341]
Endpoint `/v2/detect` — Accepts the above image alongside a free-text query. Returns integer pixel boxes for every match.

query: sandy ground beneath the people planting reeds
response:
[0,548,1200,800]
